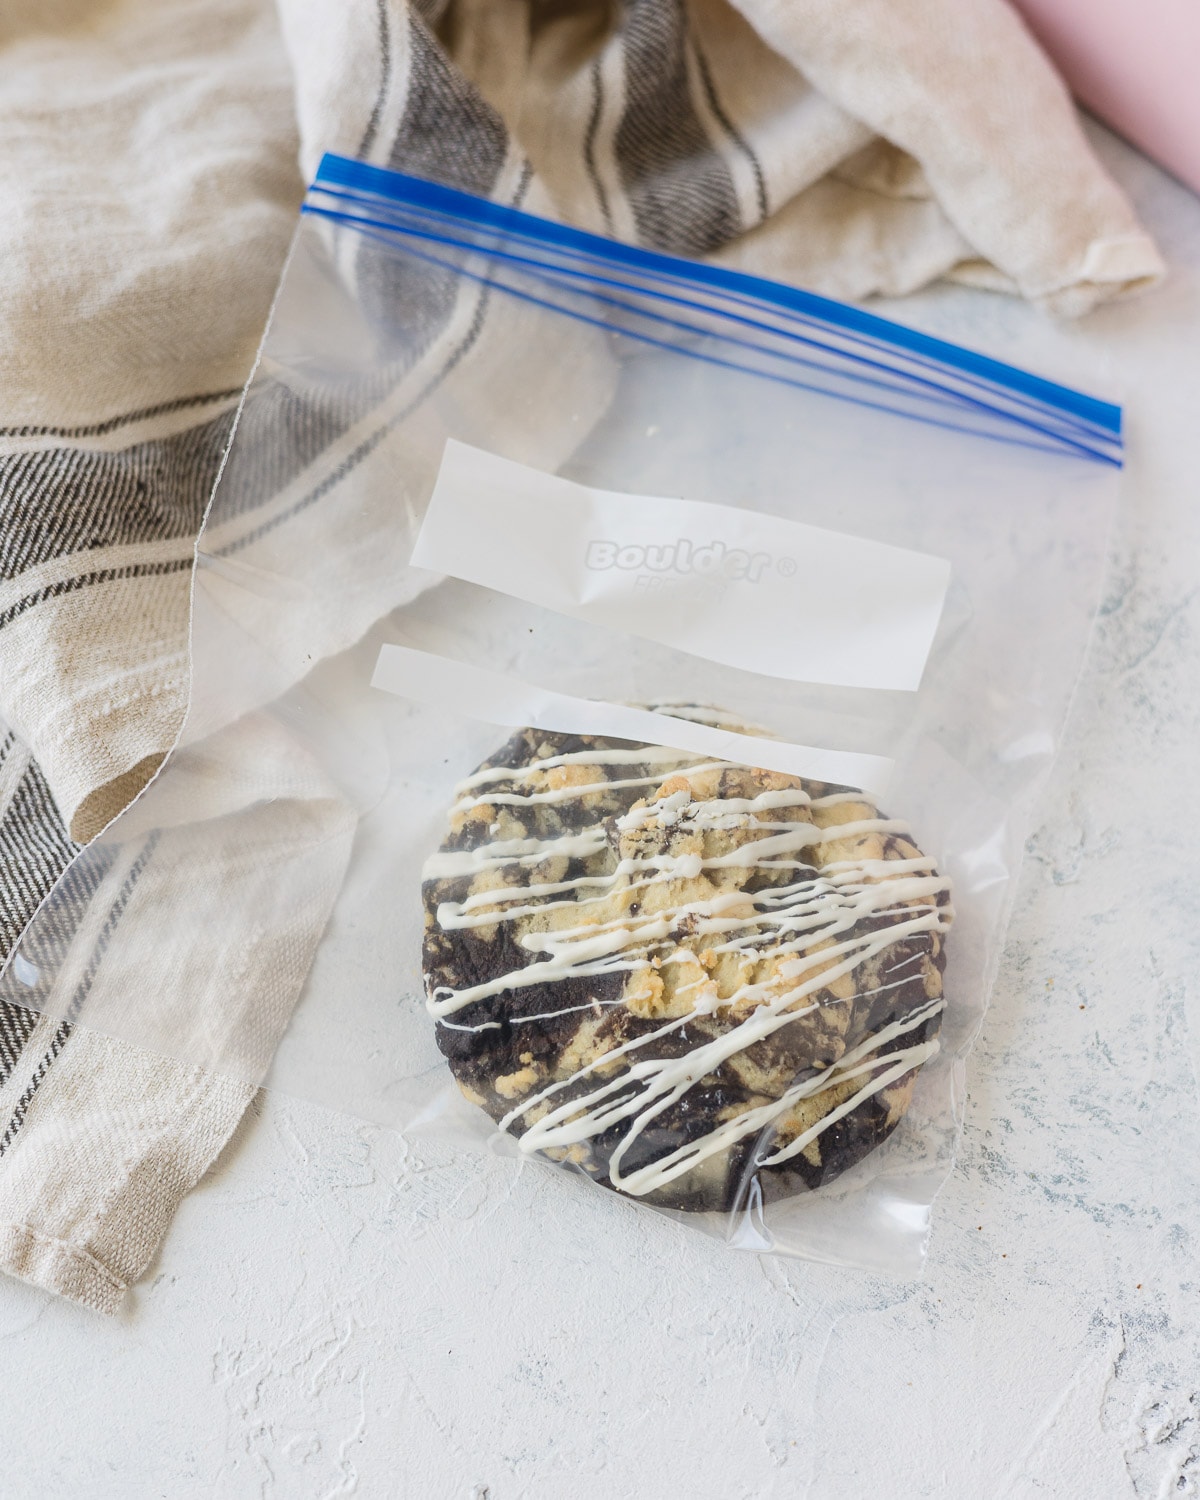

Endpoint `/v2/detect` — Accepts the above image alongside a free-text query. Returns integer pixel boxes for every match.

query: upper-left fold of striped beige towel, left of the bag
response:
[0,0,302,839]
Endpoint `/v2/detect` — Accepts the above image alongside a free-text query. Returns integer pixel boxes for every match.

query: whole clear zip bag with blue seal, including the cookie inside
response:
[0,158,1121,1271]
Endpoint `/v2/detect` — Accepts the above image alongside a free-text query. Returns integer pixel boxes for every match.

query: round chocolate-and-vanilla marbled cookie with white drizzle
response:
[423,729,951,1212]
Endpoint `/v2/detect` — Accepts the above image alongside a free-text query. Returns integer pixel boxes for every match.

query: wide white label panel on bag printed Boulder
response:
[413,440,950,690]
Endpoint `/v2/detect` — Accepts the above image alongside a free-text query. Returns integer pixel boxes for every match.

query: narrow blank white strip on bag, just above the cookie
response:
[371,645,894,797]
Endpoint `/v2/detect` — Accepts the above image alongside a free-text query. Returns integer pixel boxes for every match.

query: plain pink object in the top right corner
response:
[1014,0,1200,192]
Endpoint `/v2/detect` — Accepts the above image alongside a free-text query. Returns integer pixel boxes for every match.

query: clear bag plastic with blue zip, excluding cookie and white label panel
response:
[0,158,1121,1272]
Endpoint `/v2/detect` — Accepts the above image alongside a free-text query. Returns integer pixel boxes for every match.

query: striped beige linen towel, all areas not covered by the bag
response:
[0,0,1161,1310]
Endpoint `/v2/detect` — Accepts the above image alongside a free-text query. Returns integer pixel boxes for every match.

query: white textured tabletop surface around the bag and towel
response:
[0,132,1200,1500]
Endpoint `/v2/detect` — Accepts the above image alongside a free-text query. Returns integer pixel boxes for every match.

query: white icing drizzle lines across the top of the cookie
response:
[425,747,953,1197]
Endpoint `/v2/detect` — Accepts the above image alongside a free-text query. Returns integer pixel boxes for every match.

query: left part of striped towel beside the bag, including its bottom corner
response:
[0,0,300,1311]
